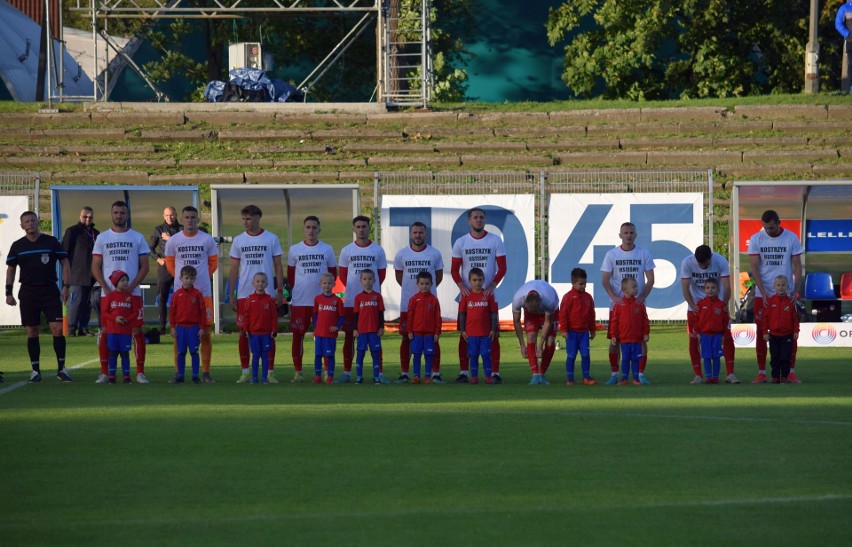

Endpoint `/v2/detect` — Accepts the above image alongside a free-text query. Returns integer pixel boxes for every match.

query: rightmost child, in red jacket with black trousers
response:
[763,275,799,384]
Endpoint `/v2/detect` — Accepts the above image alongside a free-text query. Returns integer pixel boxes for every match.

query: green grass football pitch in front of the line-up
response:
[0,326,852,546]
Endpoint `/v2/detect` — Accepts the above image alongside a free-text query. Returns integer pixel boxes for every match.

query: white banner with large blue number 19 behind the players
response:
[381,194,535,320]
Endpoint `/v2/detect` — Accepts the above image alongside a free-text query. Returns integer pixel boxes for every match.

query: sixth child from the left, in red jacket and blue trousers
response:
[408,272,444,384]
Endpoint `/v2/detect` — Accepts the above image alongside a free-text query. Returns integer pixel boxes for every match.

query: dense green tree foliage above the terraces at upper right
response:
[546,0,820,100]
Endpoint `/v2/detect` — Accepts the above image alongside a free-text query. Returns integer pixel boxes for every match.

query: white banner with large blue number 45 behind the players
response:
[547,193,704,320]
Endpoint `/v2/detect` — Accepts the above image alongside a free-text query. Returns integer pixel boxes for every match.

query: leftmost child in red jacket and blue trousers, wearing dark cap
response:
[103,270,142,384]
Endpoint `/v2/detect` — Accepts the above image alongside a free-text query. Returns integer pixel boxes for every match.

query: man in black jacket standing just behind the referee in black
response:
[62,206,100,336]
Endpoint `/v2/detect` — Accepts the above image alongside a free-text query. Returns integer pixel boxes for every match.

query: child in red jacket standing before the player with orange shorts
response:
[169,266,207,384]
